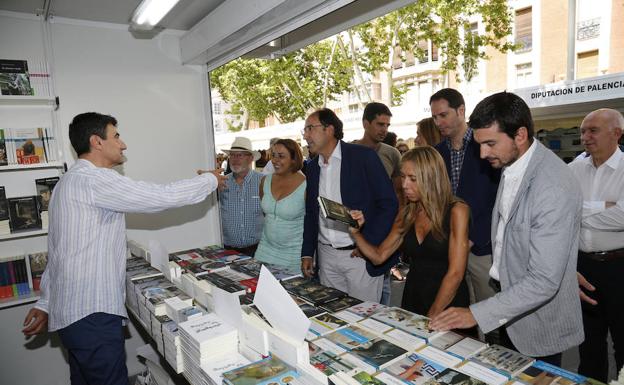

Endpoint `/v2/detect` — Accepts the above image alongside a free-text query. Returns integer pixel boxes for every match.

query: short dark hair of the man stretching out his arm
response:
[69,112,117,156]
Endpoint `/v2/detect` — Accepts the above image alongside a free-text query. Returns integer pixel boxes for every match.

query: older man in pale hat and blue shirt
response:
[219,137,264,257]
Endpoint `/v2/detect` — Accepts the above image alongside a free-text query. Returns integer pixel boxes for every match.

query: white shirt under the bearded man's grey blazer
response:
[490,139,537,281]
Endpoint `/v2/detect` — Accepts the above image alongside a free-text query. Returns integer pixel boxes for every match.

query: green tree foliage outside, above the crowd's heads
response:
[210,0,514,129]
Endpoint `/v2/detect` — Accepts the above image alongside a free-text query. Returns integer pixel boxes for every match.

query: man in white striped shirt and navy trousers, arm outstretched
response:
[23,112,225,384]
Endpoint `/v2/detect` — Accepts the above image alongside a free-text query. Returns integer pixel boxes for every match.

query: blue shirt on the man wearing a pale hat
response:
[219,170,264,248]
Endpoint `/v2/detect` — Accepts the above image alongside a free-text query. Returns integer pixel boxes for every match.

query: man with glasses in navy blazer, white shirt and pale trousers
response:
[301,108,398,302]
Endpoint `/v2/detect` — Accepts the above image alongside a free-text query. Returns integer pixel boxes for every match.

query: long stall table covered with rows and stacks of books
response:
[126,241,600,385]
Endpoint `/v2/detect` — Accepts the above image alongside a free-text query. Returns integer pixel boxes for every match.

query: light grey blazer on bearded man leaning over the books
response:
[470,139,584,357]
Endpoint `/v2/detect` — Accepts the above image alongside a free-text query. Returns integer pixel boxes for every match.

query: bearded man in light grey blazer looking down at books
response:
[430,92,584,365]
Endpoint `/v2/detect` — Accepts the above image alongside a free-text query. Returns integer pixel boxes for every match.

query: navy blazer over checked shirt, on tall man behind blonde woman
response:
[435,138,501,255]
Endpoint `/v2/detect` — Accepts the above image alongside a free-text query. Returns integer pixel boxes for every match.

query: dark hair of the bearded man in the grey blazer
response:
[468,92,533,143]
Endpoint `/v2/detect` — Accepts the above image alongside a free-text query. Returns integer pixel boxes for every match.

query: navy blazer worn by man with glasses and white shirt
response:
[301,141,399,277]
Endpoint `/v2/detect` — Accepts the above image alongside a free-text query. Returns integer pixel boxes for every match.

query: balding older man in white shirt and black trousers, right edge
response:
[569,109,624,382]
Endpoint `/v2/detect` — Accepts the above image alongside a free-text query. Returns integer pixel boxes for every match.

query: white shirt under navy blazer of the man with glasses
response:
[318,141,354,247]
